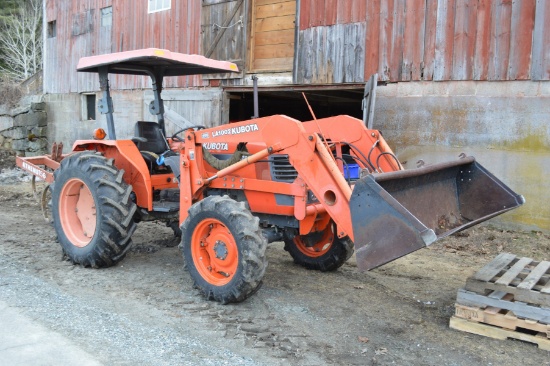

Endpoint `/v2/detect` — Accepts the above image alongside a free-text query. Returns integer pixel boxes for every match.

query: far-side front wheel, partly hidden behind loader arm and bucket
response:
[285,224,354,272]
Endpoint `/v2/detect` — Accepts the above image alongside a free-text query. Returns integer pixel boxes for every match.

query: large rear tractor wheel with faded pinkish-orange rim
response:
[51,151,137,268]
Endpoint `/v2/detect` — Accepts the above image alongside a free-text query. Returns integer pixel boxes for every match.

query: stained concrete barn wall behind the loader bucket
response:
[374,81,550,231]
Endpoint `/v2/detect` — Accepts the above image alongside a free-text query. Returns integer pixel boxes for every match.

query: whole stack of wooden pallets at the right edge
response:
[450,253,550,351]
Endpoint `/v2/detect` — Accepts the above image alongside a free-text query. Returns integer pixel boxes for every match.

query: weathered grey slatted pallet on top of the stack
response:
[465,253,550,308]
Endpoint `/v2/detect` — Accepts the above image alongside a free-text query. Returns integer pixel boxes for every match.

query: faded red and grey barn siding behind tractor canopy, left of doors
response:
[44,0,203,93]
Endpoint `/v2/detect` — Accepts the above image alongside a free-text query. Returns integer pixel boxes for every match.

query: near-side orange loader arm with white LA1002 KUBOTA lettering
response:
[180,115,353,239]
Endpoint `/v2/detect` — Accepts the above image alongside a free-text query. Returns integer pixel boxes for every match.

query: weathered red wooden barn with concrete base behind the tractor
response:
[44,0,550,231]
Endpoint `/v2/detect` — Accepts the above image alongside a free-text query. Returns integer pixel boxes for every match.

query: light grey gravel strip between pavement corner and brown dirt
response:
[0,258,258,365]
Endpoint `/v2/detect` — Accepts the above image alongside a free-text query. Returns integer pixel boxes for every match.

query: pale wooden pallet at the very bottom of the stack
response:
[449,316,550,351]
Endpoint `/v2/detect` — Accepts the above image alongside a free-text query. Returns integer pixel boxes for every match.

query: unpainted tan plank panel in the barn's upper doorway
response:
[249,0,296,72]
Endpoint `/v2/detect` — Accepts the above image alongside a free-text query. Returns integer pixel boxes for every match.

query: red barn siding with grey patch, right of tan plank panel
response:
[295,0,550,83]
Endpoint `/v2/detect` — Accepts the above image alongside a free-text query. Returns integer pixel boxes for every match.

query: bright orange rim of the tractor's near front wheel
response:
[191,219,239,286]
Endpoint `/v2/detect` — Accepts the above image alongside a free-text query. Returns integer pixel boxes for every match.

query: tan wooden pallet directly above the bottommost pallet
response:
[455,304,550,339]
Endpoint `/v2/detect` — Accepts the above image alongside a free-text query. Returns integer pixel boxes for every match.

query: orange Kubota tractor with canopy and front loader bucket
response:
[18,49,524,303]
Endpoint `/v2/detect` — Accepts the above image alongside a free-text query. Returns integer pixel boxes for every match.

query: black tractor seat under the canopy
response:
[132,121,174,171]
